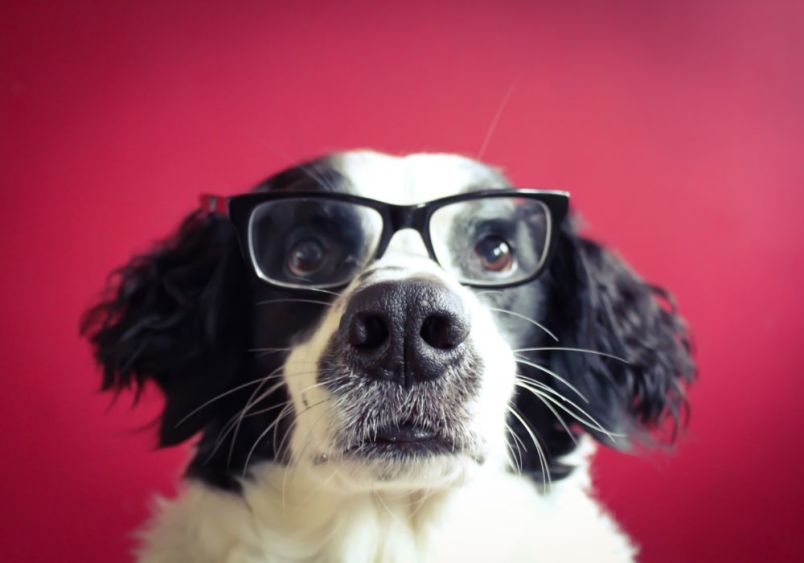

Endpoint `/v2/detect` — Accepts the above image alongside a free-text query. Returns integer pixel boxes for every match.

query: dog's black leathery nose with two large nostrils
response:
[339,280,469,387]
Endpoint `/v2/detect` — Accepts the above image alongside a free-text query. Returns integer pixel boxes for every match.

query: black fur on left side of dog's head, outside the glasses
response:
[81,159,341,490]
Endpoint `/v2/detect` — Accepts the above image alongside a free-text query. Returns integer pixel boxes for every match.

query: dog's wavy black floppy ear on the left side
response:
[81,213,250,446]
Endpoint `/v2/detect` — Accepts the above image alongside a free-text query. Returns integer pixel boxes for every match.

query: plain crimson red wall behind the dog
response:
[0,0,804,562]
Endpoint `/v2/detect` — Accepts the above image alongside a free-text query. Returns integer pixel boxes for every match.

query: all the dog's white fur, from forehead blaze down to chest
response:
[133,151,635,563]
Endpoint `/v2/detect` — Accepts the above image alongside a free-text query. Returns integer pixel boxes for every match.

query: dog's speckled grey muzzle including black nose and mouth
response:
[318,274,483,464]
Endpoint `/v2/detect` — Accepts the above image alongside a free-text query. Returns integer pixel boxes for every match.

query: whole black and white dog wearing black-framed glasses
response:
[83,151,694,563]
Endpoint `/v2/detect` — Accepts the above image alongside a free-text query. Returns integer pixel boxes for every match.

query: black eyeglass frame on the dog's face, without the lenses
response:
[201,188,570,290]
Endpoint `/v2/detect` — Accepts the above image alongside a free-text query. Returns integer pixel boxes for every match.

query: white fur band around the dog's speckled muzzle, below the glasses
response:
[284,251,516,489]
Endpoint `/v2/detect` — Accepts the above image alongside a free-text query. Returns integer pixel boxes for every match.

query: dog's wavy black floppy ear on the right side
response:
[546,225,695,447]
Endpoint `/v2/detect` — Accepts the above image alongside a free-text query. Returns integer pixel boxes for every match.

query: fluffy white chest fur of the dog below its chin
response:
[141,464,634,563]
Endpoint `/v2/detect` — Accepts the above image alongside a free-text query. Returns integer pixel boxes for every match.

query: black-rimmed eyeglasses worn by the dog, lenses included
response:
[201,188,569,289]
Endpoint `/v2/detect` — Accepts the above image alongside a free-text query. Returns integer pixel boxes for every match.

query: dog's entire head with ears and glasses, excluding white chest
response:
[83,152,694,487]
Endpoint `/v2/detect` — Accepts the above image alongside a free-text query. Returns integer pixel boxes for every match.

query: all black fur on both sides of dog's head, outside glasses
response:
[82,159,694,489]
